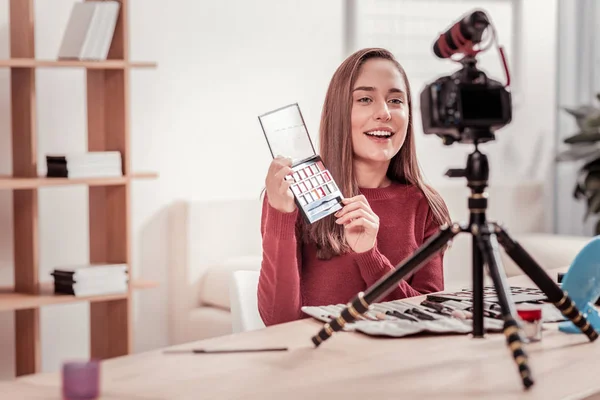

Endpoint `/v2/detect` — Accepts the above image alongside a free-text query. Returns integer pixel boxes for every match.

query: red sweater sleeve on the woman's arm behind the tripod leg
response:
[355,212,444,301]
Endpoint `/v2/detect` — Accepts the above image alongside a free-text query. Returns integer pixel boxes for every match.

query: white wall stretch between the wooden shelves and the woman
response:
[126,0,343,350]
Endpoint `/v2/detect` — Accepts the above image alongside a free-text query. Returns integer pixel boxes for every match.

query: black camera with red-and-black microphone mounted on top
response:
[420,11,512,145]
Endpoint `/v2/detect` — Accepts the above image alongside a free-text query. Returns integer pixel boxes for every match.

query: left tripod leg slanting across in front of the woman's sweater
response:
[312,223,463,346]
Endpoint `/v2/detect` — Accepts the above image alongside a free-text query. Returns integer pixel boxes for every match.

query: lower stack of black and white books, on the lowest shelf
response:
[51,264,128,297]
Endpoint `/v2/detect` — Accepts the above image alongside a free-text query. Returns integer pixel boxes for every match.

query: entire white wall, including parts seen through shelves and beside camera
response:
[0,0,556,378]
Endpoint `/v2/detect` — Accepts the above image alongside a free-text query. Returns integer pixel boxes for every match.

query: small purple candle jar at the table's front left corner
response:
[62,360,100,400]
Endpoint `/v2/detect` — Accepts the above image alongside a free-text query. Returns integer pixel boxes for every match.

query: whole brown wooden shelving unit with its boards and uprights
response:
[0,0,156,376]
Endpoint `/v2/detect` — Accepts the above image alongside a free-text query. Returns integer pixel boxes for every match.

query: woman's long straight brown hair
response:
[305,48,450,259]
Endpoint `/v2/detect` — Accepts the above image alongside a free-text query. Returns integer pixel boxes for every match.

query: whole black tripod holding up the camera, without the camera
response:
[312,140,598,389]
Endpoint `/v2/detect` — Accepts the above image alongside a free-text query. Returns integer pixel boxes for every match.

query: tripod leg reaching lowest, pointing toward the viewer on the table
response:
[477,232,533,389]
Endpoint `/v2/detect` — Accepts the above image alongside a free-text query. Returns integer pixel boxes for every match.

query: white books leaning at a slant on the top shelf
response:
[58,0,120,61]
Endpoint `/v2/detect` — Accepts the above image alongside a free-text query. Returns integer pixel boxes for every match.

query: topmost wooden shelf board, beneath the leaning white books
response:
[0,58,156,69]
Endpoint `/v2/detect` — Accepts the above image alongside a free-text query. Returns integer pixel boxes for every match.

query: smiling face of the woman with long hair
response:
[351,58,409,165]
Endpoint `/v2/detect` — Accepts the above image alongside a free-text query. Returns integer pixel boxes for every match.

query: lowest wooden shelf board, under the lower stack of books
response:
[0,281,158,312]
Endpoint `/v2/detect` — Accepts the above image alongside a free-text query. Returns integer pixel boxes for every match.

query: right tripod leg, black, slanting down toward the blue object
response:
[494,224,598,342]
